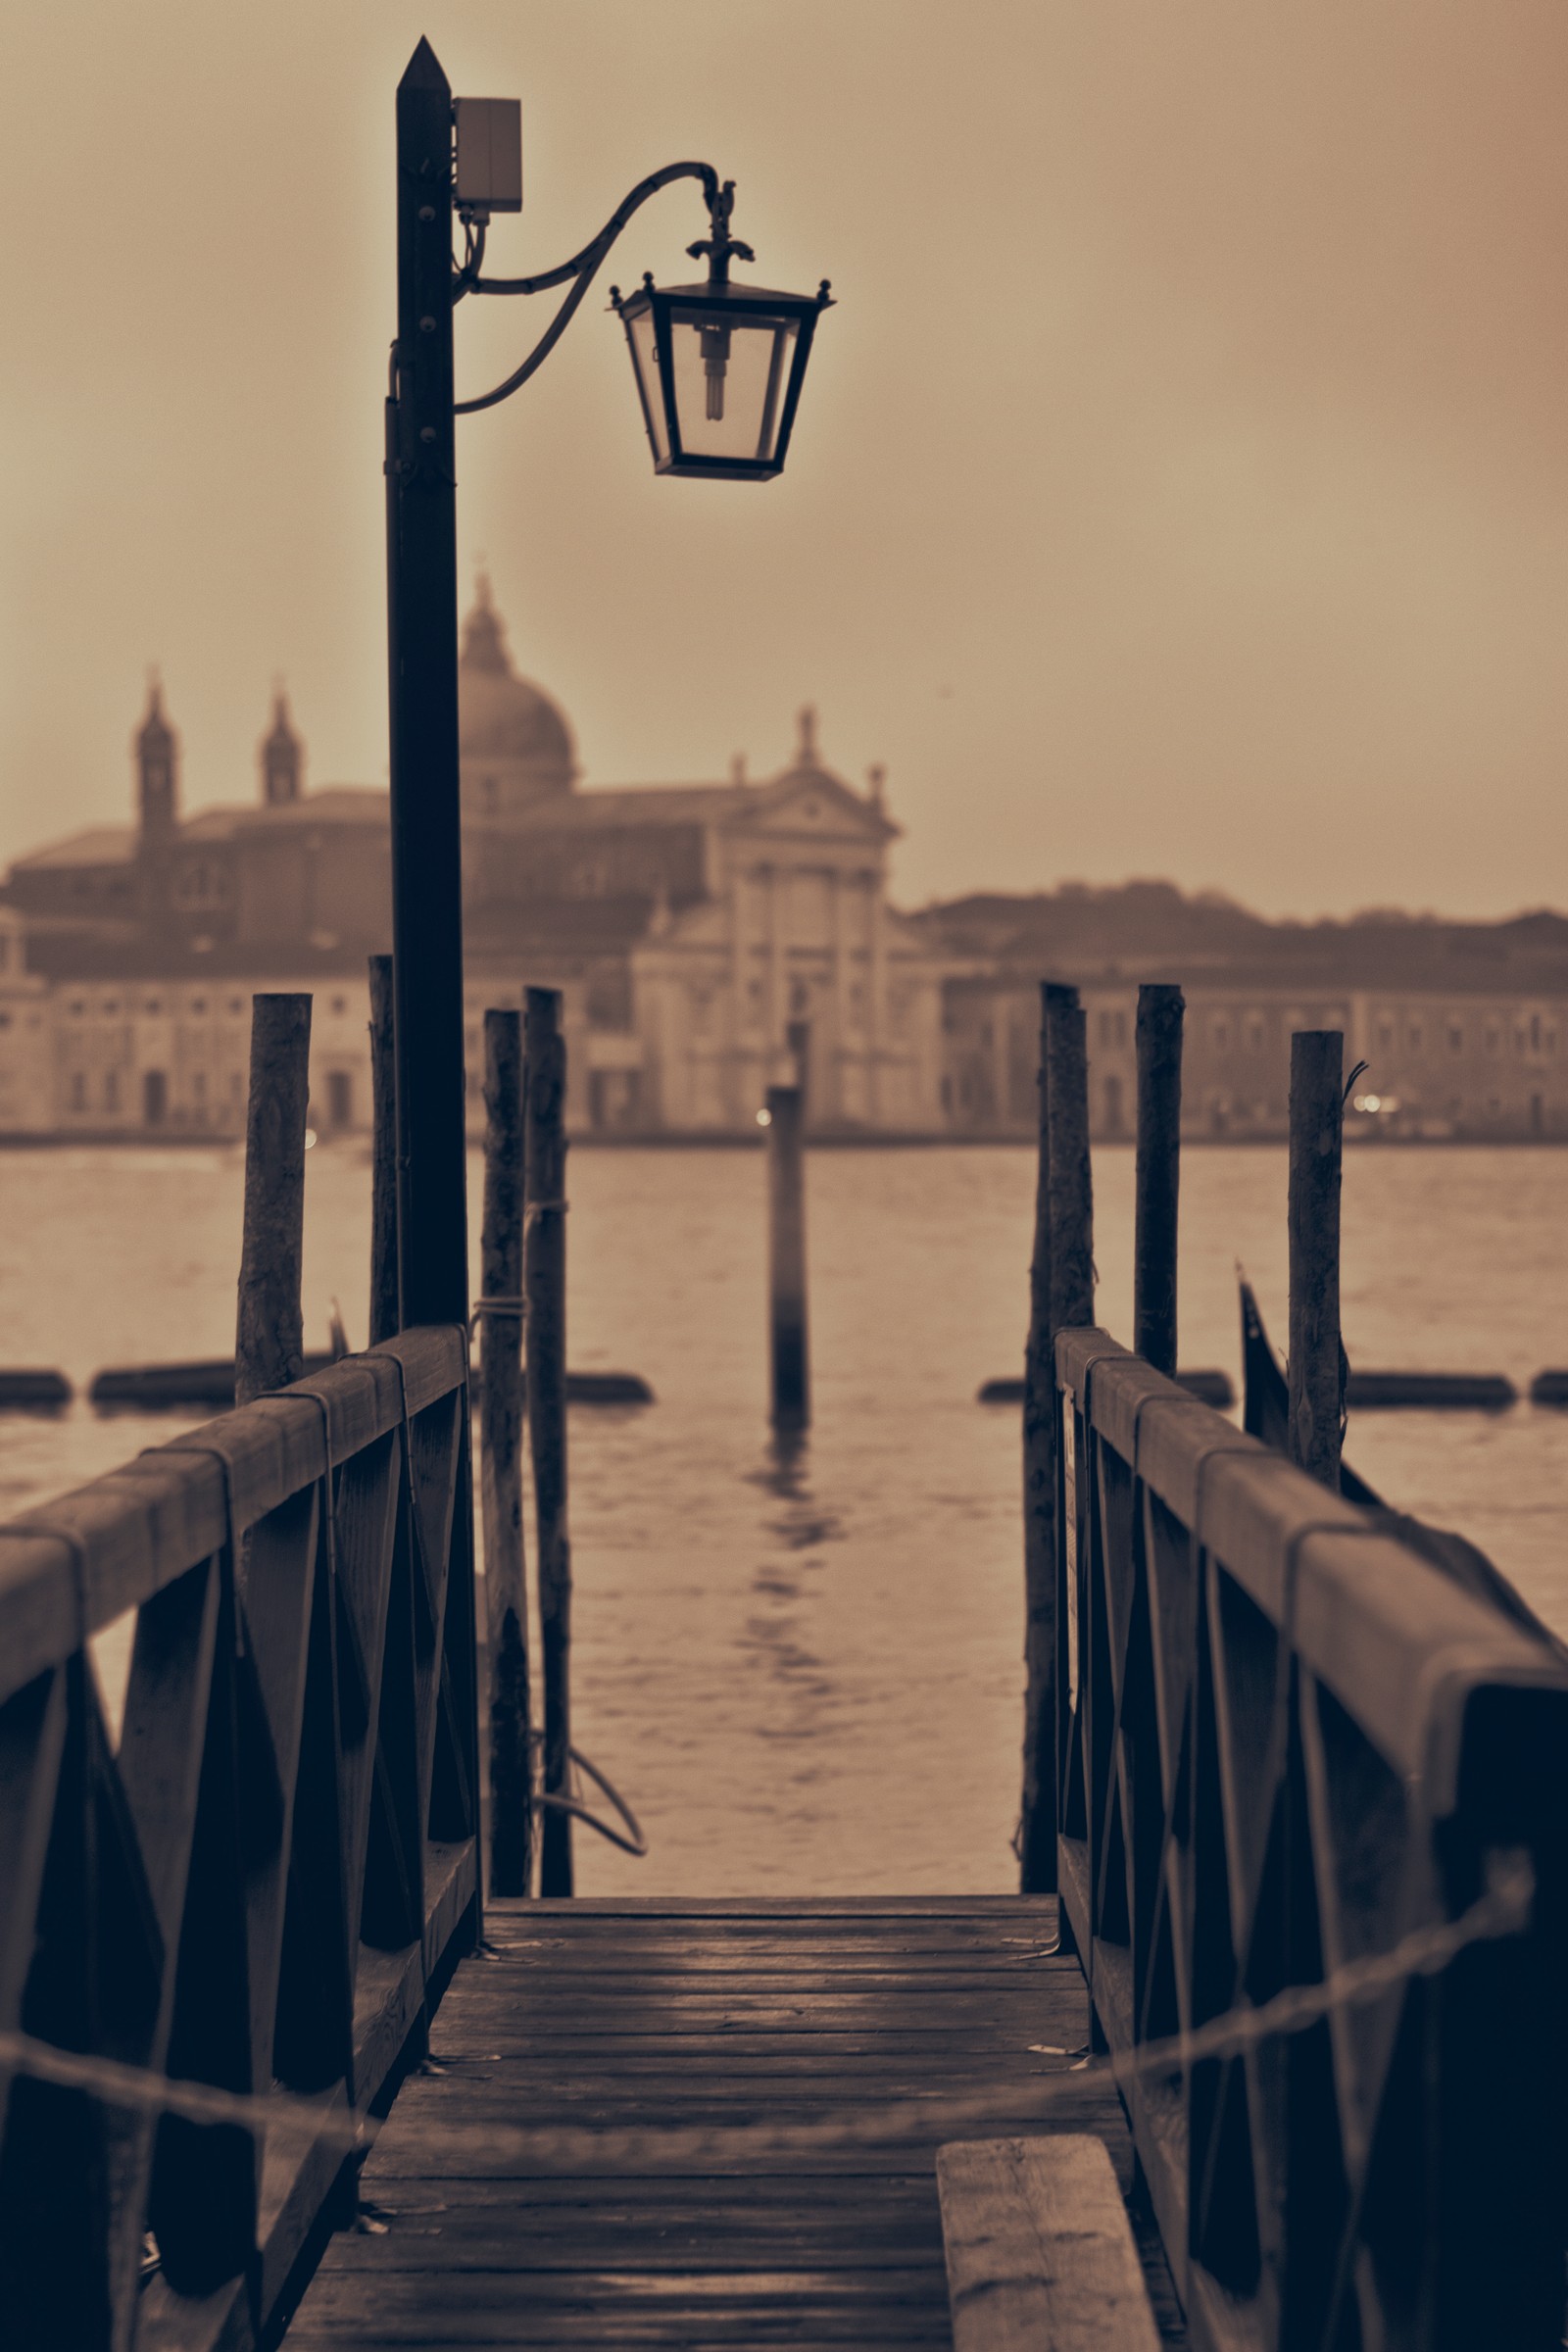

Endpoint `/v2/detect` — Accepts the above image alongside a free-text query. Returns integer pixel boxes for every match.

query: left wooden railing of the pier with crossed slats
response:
[0,1329,477,2352]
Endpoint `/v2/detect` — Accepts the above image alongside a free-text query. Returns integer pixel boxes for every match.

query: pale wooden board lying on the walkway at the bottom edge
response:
[936,2131,1159,2352]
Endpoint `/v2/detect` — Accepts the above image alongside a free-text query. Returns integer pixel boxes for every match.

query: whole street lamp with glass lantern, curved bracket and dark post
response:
[385,40,827,1327]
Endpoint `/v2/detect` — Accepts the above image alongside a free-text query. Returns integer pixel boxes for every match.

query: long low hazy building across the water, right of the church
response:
[921,884,1568,1141]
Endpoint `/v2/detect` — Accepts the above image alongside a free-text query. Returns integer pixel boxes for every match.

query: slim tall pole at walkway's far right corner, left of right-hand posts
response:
[1018,981,1055,1895]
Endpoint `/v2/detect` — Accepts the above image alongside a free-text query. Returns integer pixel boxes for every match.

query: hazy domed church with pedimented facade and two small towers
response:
[0,583,953,1136]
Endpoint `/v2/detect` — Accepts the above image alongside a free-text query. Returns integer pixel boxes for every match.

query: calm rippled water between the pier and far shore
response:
[0,1146,1568,1893]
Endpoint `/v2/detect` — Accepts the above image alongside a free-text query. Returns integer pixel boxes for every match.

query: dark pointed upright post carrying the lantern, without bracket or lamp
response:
[385,40,467,1327]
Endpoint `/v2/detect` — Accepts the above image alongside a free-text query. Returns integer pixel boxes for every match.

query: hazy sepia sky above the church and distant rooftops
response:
[0,0,1568,915]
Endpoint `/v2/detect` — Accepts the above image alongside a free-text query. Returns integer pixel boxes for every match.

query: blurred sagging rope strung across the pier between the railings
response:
[0,1851,1535,2171]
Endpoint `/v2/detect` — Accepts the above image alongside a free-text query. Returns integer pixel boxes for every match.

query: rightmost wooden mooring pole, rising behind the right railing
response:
[1286,1030,1345,1494]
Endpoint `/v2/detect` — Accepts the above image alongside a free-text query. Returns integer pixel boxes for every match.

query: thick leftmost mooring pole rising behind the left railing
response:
[235,998,311,1404]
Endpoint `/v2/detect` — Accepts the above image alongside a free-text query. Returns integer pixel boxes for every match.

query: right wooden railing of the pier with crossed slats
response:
[1055,1331,1568,2352]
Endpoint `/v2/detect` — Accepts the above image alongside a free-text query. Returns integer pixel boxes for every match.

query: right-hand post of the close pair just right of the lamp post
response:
[524,988,571,1895]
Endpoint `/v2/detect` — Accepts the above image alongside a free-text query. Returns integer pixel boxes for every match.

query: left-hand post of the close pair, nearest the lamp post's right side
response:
[479,1009,534,1895]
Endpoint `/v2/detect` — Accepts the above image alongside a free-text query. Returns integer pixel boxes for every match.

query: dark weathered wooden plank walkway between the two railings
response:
[287,1895,1185,2352]
